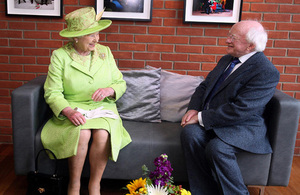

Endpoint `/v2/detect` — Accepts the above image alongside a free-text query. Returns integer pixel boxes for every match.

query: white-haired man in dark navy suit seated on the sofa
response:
[181,21,279,195]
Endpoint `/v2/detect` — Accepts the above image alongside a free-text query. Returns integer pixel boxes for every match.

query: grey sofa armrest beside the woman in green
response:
[11,76,51,175]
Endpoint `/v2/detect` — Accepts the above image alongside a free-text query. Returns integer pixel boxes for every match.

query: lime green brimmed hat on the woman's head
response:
[59,7,111,37]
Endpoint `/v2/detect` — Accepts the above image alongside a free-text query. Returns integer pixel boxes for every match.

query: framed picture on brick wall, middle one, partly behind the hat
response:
[96,0,152,21]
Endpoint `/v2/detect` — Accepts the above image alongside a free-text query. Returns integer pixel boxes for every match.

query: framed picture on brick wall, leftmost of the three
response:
[5,0,63,17]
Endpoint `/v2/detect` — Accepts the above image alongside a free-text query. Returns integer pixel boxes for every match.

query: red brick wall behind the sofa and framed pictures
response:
[0,0,300,155]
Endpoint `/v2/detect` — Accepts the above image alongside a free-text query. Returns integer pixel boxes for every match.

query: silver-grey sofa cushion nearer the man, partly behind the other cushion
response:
[147,66,204,122]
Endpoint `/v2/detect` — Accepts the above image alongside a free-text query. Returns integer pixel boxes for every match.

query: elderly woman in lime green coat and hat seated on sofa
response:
[41,7,131,195]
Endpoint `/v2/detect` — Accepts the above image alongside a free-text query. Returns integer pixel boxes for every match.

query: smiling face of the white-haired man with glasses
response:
[226,23,251,57]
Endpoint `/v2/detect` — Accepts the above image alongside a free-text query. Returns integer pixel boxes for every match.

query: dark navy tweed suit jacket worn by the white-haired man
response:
[188,52,280,154]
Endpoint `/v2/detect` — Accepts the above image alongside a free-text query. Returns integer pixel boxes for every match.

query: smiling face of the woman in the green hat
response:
[74,32,99,55]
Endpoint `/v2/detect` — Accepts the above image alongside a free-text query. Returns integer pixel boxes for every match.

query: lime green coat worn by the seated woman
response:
[41,43,131,161]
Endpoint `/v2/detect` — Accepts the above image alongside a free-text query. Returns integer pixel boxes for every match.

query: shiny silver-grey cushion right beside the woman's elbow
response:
[116,69,161,122]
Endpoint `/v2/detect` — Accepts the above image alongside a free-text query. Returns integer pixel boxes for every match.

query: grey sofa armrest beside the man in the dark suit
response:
[266,90,300,186]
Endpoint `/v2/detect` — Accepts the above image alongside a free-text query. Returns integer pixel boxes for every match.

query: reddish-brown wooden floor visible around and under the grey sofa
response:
[0,144,300,195]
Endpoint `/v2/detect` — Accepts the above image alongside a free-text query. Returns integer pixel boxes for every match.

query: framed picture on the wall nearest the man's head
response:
[184,0,242,24]
